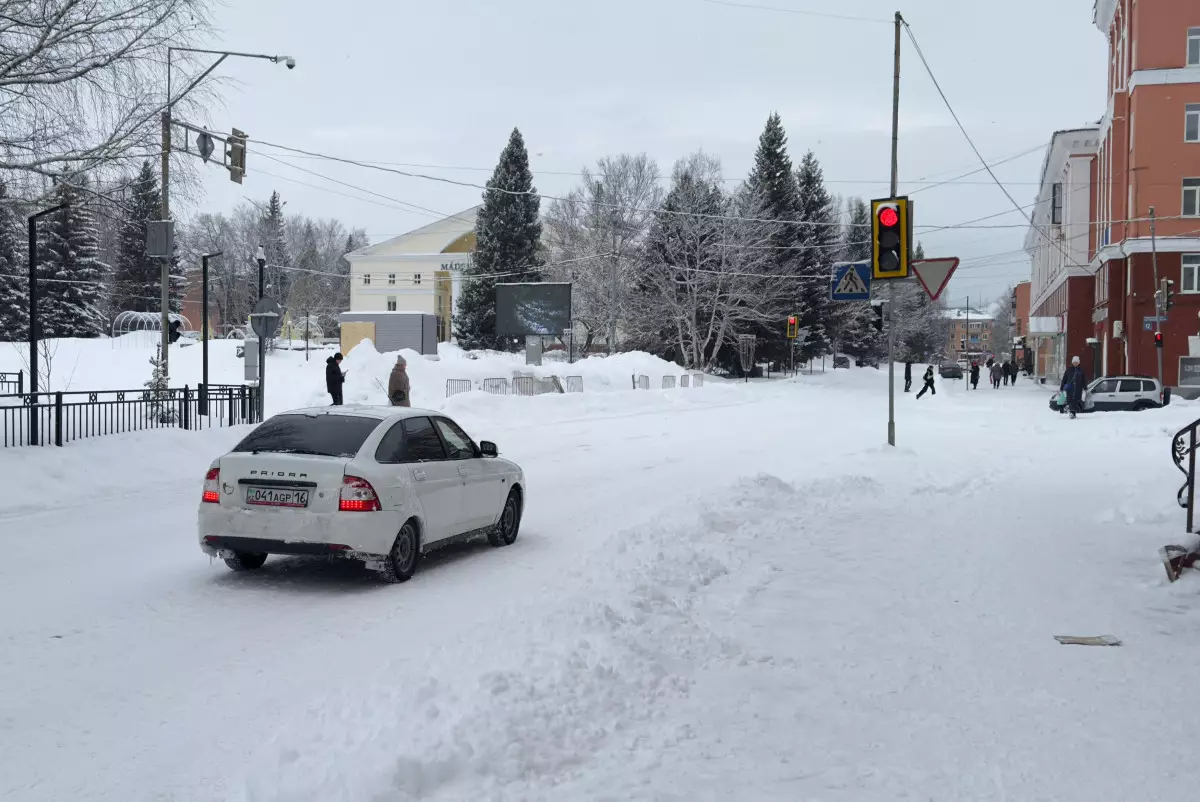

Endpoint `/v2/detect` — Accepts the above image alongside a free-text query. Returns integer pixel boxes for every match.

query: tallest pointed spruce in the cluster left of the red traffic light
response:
[746,113,804,360]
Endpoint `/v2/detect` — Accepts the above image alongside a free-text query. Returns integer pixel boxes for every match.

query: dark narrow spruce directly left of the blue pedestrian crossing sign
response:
[797,150,839,359]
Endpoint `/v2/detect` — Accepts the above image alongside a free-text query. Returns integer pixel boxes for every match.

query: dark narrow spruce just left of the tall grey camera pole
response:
[113,161,162,312]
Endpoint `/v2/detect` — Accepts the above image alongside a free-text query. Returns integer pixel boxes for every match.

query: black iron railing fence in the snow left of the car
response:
[0,384,259,448]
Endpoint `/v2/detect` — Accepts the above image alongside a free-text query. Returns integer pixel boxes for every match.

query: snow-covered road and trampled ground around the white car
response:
[0,371,1200,802]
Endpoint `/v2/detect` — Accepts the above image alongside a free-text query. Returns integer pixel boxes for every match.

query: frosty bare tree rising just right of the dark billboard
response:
[545,154,662,353]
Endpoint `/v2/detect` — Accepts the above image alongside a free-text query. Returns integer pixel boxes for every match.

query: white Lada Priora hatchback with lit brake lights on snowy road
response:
[199,407,526,582]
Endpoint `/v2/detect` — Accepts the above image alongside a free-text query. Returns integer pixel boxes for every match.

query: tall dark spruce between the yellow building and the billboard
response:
[454,128,542,349]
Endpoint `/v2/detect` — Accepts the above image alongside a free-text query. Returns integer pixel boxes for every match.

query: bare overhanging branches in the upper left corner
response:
[0,0,208,190]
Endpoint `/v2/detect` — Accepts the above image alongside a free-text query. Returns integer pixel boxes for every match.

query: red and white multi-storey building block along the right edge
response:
[1026,0,1200,385]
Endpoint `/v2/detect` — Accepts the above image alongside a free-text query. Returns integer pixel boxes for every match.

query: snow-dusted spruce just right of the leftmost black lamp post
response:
[37,178,110,337]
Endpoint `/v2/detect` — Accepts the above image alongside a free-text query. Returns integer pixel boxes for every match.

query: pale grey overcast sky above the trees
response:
[184,0,1105,305]
